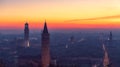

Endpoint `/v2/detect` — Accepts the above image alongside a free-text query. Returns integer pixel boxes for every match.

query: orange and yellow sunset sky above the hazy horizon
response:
[0,0,120,29]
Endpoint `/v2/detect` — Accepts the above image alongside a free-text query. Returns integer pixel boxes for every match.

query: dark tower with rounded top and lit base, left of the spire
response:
[24,23,30,47]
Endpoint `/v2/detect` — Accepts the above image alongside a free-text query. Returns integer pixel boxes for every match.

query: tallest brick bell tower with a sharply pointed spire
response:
[41,21,50,67]
